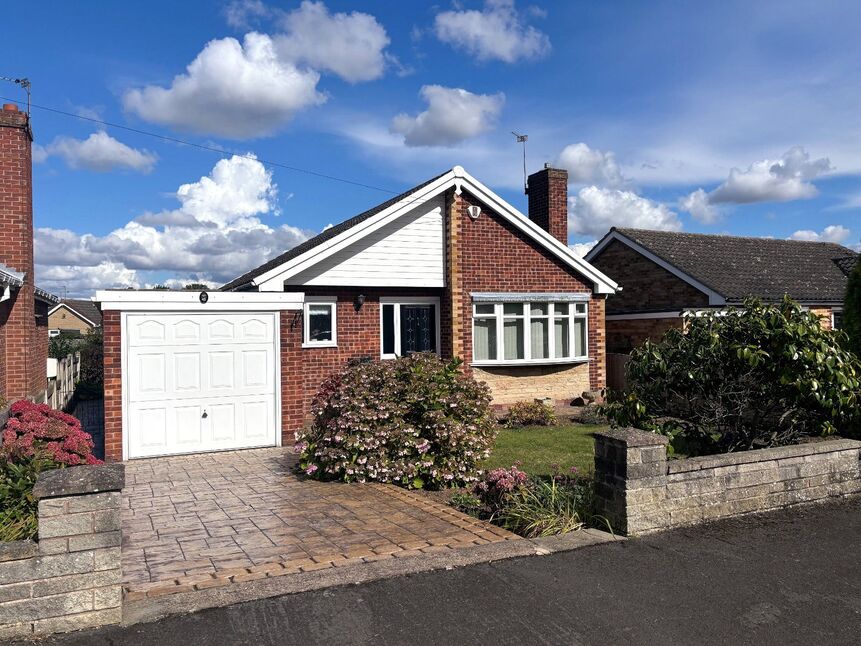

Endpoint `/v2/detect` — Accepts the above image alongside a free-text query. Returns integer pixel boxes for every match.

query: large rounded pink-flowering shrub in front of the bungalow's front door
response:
[296,353,496,489]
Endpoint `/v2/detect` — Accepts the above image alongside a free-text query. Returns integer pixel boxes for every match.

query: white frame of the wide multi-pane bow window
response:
[472,299,589,366]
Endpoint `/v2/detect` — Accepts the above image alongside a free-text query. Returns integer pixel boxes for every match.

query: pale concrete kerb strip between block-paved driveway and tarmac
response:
[122,529,627,625]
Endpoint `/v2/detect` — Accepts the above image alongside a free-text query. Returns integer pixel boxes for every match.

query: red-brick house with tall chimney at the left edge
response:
[0,104,58,401]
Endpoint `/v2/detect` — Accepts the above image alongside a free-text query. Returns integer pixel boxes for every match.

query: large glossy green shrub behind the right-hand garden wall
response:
[605,298,861,455]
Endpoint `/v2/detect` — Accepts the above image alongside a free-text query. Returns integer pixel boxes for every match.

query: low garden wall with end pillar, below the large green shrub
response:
[595,429,861,534]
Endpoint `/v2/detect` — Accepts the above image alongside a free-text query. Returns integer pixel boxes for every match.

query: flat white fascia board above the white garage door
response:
[96,290,305,312]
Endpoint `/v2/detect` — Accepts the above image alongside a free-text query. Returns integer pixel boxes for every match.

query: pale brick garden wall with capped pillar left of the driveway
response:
[0,465,124,641]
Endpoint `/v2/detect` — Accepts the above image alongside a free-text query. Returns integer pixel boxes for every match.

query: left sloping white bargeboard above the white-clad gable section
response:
[251,172,457,292]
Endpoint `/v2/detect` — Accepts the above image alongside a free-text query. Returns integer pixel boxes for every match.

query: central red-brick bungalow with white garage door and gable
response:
[96,166,616,460]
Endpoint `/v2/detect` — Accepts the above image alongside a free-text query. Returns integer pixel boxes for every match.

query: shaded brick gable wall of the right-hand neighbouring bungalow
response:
[592,240,709,314]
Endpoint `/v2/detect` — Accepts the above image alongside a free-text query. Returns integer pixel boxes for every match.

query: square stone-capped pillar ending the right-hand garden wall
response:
[595,428,668,535]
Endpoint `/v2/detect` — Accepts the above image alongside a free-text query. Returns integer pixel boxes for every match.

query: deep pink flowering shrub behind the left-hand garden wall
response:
[0,399,101,466]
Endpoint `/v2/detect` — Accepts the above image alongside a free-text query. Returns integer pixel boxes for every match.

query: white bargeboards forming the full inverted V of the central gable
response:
[252,166,619,294]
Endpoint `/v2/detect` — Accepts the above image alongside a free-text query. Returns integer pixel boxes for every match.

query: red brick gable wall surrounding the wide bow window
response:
[447,191,606,390]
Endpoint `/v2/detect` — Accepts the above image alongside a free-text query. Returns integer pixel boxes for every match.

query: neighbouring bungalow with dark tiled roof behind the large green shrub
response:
[586,228,858,353]
